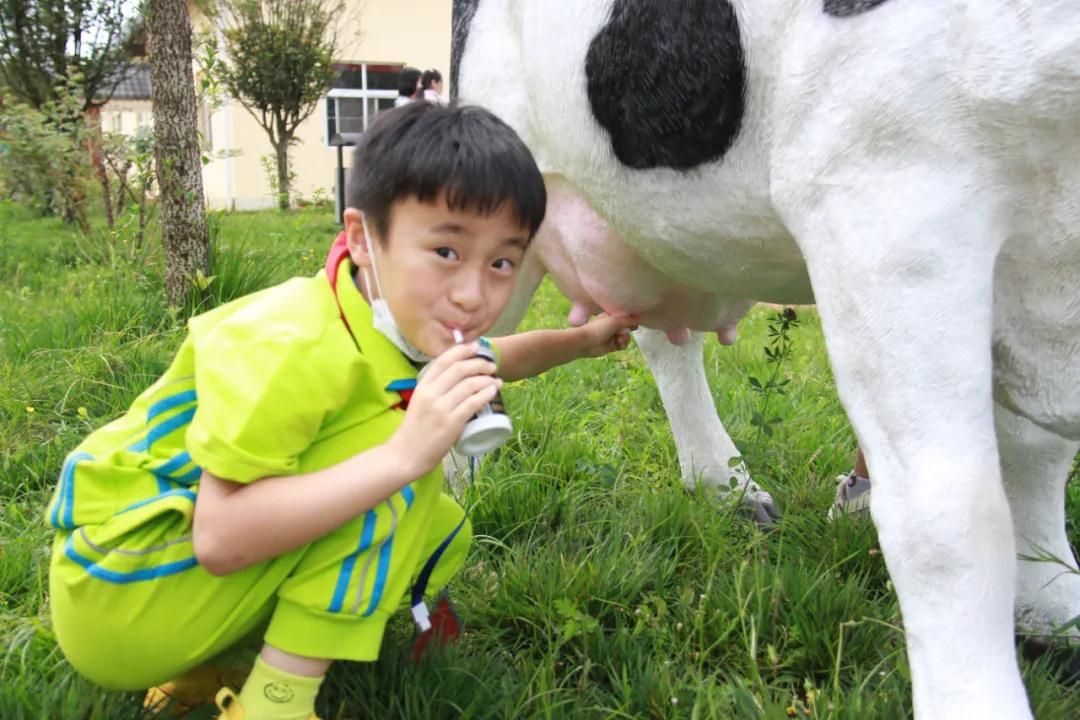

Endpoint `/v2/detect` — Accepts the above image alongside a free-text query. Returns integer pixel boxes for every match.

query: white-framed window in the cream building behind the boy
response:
[323,63,404,147]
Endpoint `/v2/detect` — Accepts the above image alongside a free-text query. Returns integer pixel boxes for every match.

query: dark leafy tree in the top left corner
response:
[0,0,137,111]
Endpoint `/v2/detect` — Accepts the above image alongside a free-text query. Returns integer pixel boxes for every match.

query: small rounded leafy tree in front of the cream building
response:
[220,0,347,209]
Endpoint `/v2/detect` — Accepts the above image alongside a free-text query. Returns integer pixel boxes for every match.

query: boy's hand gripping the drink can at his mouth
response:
[388,342,502,477]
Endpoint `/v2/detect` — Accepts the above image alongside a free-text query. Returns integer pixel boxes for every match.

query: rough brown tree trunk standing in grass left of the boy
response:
[147,0,210,305]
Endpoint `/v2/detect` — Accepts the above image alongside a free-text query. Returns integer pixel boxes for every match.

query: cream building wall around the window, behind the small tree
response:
[200,0,450,209]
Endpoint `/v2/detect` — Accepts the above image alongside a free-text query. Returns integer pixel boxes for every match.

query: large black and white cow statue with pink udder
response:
[454,0,1080,719]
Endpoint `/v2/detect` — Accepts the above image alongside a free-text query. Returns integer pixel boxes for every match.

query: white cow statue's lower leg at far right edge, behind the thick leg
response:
[995,406,1080,639]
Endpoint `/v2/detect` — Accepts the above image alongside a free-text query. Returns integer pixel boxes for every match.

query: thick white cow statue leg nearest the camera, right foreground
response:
[792,208,1031,720]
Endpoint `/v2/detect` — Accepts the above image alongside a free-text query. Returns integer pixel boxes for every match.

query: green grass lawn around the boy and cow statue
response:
[0,198,1080,720]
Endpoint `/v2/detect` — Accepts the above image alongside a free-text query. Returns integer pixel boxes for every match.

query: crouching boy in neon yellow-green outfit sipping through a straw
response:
[48,103,633,720]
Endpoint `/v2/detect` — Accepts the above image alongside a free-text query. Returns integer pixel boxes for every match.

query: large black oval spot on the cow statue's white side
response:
[585,0,746,169]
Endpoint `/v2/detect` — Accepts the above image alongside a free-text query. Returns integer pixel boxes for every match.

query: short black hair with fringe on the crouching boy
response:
[346,103,548,239]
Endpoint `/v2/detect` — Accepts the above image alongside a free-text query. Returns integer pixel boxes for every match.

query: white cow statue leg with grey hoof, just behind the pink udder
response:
[634,328,779,524]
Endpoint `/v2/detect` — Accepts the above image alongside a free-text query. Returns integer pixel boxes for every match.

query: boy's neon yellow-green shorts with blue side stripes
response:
[50,468,472,690]
